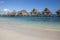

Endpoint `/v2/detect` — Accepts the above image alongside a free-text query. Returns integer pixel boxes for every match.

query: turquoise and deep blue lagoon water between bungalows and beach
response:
[0,16,60,29]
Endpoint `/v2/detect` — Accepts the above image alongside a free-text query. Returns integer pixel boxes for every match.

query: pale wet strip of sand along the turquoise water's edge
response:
[0,20,60,31]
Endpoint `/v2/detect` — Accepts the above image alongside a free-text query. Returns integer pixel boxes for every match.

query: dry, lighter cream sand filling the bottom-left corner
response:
[0,28,40,40]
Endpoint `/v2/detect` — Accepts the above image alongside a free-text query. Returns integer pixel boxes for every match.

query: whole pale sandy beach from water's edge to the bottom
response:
[0,20,60,40]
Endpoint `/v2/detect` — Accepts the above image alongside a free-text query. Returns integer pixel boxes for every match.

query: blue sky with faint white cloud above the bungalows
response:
[0,0,60,12]
